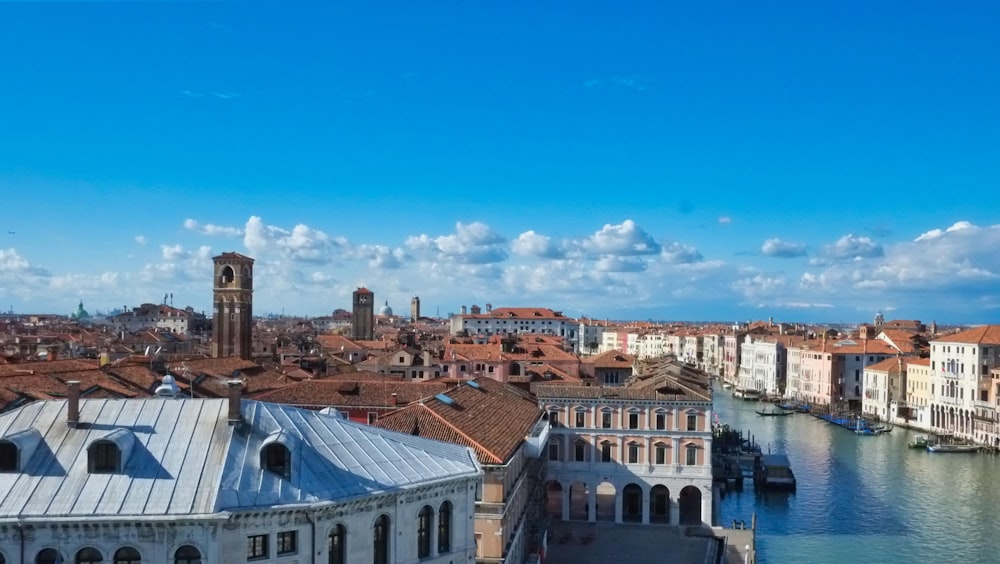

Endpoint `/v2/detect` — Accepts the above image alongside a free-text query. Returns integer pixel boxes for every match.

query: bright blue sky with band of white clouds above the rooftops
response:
[0,1,1000,323]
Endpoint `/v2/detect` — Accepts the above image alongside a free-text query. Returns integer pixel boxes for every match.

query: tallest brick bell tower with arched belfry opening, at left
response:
[212,253,253,360]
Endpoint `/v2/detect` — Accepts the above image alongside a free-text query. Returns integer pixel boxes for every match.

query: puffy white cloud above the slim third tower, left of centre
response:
[406,221,507,264]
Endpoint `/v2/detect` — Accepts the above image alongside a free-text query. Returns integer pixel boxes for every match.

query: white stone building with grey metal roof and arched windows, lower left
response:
[0,383,482,564]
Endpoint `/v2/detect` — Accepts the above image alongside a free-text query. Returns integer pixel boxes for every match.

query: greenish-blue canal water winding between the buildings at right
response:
[715,389,1000,564]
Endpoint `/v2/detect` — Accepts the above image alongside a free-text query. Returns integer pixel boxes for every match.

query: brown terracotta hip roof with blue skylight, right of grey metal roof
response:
[376,378,542,464]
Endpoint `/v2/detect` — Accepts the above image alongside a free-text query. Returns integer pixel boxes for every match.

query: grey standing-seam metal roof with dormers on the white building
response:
[0,398,480,519]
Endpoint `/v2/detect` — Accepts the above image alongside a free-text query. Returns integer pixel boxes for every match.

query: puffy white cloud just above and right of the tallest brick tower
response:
[243,216,349,262]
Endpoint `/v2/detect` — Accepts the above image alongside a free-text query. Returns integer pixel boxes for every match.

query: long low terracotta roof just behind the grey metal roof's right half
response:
[254,378,448,407]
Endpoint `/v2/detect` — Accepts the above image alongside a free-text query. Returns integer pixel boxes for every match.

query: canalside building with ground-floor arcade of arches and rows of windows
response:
[534,363,713,526]
